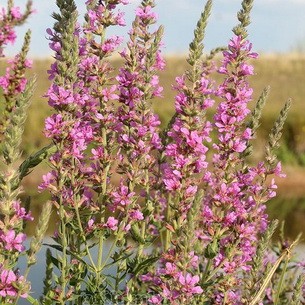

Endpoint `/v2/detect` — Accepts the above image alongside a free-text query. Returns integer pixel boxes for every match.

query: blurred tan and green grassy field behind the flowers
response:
[0,54,305,236]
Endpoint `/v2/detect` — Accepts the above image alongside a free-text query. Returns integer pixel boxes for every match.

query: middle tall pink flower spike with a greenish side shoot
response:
[118,0,163,247]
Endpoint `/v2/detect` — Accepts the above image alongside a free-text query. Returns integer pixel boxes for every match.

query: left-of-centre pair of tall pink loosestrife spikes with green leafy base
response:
[41,1,156,304]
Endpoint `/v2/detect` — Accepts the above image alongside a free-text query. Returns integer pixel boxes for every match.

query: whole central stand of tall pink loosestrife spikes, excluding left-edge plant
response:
[41,0,302,304]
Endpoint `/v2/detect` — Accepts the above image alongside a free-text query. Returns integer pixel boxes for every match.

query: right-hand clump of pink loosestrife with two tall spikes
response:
[138,1,302,304]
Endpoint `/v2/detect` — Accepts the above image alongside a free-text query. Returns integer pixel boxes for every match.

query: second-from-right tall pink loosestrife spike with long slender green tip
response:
[142,1,215,304]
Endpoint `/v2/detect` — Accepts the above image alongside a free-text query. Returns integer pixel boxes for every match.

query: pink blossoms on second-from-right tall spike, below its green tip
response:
[162,73,214,219]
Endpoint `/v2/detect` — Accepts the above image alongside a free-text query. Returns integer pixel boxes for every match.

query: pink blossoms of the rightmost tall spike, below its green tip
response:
[190,36,281,304]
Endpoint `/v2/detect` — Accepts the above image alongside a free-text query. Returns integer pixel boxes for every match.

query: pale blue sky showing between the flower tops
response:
[5,0,305,57]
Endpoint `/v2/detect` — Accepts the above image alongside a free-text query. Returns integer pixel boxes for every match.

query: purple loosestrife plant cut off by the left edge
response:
[0,1,51,304]
